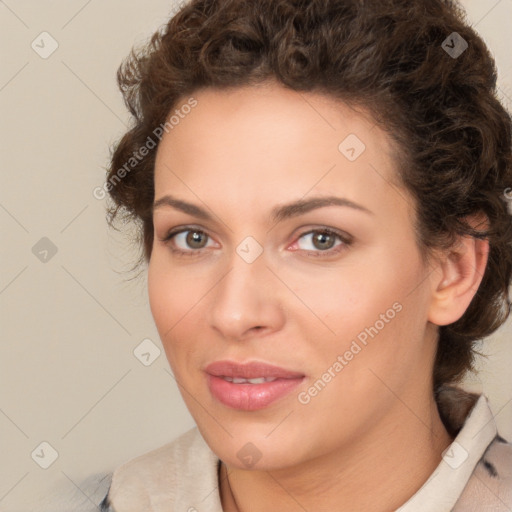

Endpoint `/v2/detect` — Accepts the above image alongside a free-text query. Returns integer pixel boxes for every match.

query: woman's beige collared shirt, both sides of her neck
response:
[100,387,512,512]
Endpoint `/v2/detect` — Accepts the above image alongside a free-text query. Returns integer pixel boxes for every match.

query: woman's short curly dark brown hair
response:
[107,0,512,390]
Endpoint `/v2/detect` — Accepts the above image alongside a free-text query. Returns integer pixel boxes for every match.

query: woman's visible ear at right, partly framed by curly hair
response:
[428,215,489,325]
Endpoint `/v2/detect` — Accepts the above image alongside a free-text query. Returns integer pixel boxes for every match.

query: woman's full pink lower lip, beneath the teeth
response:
[208,374,304,411]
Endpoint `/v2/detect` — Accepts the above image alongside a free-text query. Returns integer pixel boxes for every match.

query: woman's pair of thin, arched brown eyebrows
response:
[153,195,374,223]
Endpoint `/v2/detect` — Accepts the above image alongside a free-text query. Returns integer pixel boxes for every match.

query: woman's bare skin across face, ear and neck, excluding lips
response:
[148,82,488,512]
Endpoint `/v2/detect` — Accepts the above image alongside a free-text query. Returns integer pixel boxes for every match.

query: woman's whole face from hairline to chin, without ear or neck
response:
[148,85,435,469]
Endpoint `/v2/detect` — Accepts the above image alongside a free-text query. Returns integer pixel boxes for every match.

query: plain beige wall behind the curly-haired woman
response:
[0,0,512,512]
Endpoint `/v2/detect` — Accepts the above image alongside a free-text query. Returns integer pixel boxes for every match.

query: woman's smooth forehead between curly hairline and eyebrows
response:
[155,84,412,220]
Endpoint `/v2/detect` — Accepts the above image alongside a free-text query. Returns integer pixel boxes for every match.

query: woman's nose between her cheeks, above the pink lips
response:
[209,253,285,340]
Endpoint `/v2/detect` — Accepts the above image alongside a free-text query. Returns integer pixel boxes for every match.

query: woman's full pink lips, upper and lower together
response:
[205,361,305,411]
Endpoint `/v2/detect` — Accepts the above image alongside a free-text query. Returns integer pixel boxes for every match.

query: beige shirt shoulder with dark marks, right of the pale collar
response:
[454,435,512,512]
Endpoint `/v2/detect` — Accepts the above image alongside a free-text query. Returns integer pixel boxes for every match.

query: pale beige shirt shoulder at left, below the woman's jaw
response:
[101,427,214,512]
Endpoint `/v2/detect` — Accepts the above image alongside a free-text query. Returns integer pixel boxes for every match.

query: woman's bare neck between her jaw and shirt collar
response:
[220,390,453,512]
